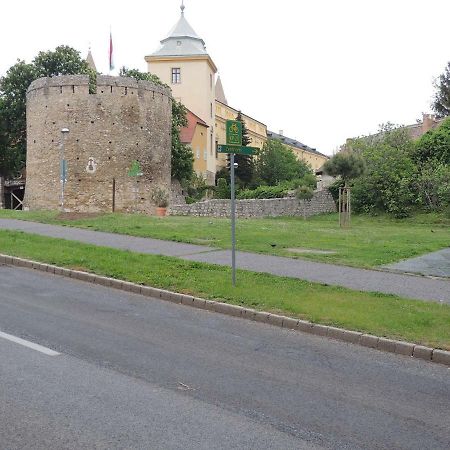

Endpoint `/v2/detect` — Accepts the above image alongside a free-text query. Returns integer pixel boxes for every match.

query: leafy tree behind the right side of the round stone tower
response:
[120,67,194,181]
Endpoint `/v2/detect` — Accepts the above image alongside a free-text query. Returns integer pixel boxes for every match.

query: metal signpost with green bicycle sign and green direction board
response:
[221,120,257,286]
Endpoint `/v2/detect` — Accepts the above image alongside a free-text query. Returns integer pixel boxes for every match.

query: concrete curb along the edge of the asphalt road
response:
[0,254,450,367]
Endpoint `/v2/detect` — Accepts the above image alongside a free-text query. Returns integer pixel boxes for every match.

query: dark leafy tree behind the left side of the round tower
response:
[0,46,95,176]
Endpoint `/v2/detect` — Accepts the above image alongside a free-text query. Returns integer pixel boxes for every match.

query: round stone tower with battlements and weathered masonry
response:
[25,75,172,213]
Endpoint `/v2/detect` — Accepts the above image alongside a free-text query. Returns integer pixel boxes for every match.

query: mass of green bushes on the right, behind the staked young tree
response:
[338,122,450,217]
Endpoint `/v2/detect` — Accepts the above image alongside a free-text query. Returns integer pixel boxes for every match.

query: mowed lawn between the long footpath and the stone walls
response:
[0,210,450,267]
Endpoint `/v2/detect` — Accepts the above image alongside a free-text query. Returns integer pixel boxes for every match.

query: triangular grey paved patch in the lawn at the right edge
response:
[384,248,450,277]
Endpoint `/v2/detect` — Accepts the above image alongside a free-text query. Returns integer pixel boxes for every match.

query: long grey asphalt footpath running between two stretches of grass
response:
[0,219,450,304]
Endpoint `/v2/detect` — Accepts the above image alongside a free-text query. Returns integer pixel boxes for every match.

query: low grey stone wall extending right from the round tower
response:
[170,190,336,218]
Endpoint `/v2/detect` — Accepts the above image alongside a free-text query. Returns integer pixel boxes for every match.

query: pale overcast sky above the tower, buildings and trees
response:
[0,0,450,154]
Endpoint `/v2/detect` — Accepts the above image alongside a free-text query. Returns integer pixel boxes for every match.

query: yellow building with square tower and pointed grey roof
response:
[145,5,328,184]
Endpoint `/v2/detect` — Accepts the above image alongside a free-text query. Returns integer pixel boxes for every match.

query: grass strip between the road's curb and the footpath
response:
[0,230,450,350]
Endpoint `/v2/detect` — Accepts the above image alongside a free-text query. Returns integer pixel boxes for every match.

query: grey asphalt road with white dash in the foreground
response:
[0,266,450,450]
